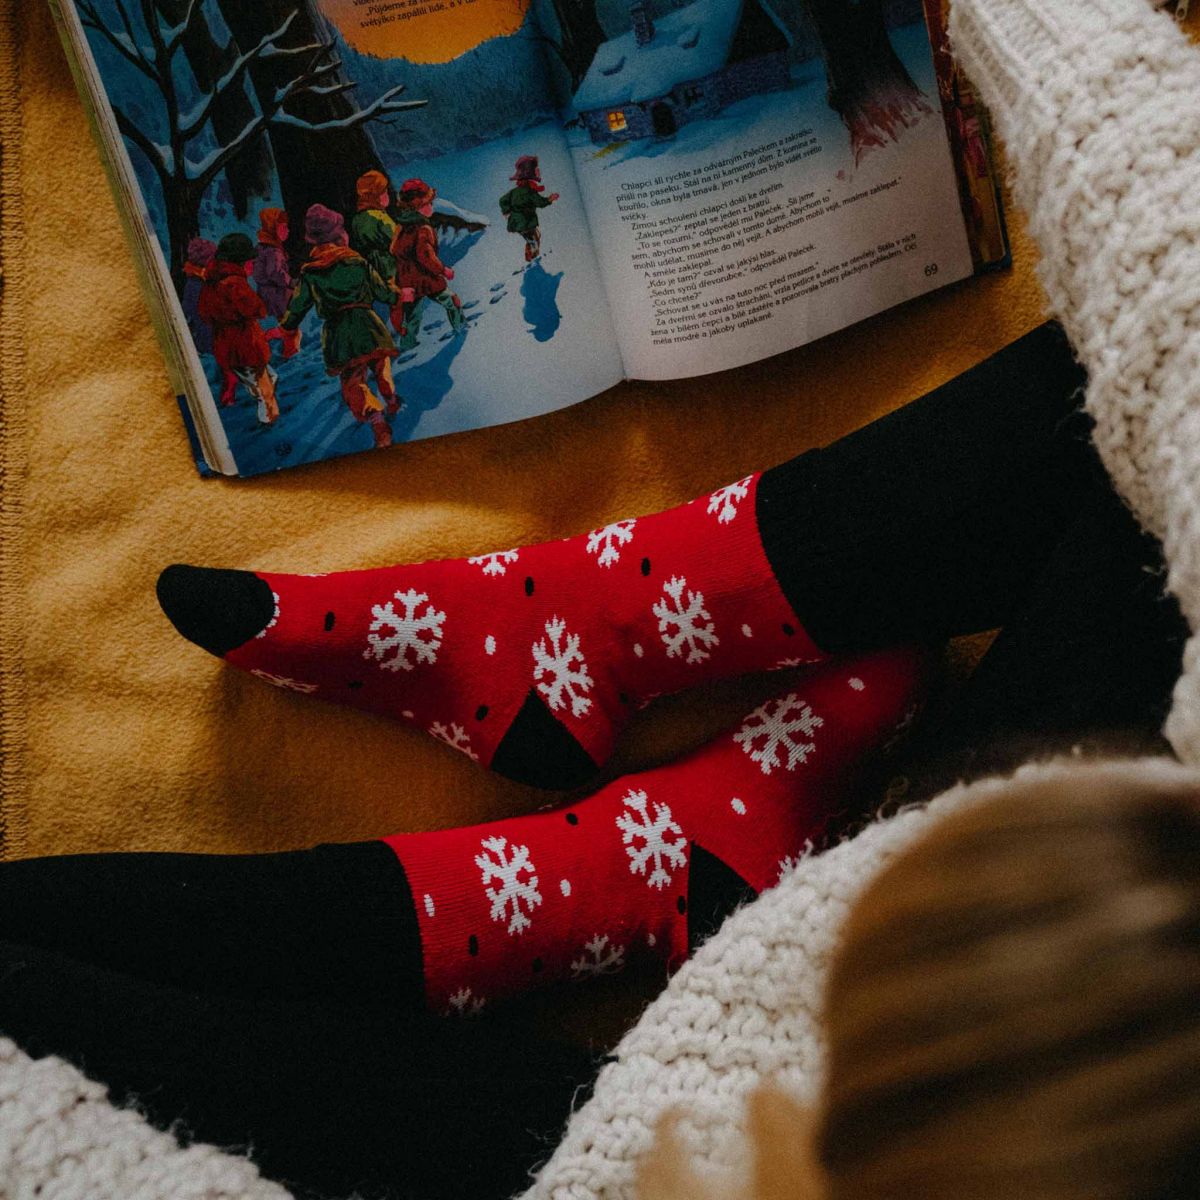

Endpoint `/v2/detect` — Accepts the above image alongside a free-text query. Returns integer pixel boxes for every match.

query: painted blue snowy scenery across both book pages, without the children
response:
[76,0,945,473]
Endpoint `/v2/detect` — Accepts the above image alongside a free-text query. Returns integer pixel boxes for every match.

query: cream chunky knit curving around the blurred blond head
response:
[522,758,1200,1200]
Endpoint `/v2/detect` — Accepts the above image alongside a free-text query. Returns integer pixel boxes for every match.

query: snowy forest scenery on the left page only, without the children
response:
[76,0,620,473]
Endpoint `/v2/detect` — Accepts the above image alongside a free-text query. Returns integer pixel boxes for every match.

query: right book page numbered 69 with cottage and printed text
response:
[539,0,973,379]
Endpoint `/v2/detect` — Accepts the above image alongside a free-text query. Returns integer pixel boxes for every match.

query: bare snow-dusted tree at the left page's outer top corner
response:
[77,0,425,290]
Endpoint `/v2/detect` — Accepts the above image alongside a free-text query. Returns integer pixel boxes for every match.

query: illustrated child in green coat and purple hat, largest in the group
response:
[280,204,401,446]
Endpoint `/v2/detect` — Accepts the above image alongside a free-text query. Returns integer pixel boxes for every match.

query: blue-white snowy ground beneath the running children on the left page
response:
[203,124,622,474]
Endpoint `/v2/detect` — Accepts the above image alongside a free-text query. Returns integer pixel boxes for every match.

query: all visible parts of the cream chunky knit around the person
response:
[0,0,1200,1200]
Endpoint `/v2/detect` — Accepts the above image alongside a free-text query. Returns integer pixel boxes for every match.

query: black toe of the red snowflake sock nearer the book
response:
[157,564,275,658]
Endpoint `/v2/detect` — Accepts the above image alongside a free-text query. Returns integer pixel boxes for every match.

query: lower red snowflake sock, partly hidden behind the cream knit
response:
[385,649,924,1013]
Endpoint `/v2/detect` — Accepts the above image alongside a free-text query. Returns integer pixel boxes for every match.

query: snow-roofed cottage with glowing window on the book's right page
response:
[575,0,792,145]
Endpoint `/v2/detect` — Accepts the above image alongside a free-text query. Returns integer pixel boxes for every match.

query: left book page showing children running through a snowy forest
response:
[55,0,623,475]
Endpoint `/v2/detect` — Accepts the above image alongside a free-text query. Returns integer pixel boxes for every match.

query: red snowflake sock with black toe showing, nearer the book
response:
[158,475,823,787]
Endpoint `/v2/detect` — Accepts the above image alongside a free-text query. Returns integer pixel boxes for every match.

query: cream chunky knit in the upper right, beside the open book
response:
[950,0,1200,763]
